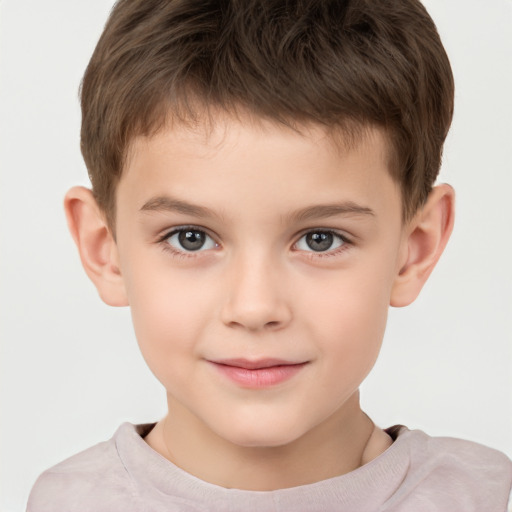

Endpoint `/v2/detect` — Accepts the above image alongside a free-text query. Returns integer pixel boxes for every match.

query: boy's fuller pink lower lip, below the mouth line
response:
[213,363,307,389]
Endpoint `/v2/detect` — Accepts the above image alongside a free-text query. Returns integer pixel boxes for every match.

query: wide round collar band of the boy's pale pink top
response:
[114,423,416,512]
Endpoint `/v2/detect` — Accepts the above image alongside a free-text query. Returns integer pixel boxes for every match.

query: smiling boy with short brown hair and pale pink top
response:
[28,0,512,511]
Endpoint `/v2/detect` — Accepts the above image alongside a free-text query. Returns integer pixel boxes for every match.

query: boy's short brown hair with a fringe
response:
[81,0,454,226]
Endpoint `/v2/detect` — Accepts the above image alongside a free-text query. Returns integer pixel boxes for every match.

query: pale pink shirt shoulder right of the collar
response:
[392,429,512,511]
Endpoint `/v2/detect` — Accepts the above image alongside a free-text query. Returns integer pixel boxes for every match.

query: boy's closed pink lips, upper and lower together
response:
[209,359,308,389]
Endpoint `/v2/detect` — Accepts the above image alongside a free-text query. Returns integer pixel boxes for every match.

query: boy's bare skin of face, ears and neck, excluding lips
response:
[66,113,453,490]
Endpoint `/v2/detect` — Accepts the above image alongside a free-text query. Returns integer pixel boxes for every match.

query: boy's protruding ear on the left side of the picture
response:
[64,187,128,306]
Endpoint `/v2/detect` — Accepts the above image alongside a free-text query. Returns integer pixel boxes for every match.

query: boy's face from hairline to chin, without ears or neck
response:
[116,119,405,446]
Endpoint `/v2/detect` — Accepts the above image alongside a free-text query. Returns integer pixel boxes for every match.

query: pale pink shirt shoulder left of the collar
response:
[27,424,142,512]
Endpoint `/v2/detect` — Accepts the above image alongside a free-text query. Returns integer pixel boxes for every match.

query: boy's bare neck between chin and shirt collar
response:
[146,393,389,491]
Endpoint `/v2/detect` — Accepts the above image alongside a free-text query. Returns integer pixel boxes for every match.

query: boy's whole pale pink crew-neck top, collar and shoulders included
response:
[27,423,512,512]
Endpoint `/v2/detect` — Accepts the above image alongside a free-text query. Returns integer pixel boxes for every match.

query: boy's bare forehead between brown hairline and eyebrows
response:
[118,115,400,223]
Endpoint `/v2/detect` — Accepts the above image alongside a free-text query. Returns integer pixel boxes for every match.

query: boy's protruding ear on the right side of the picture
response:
[390,184,455,307]
